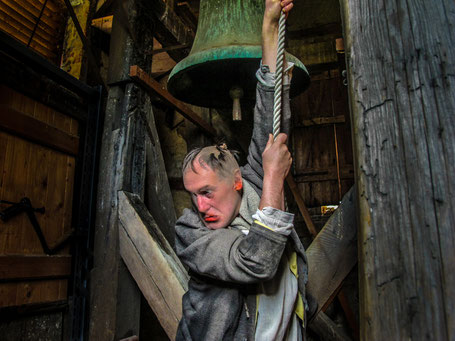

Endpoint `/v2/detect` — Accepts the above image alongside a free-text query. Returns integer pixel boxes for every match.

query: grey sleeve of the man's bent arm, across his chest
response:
[176,209,287,284]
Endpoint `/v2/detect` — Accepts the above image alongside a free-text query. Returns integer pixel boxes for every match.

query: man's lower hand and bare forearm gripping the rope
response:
[259,133,292,210]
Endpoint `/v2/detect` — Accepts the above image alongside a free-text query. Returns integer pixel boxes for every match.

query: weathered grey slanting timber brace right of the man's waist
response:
[306,188,357,314]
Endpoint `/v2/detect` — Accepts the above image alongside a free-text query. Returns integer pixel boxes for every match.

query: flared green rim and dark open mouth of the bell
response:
[168,45,310,108]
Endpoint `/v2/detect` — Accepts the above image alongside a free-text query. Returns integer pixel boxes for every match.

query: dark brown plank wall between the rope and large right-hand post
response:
[291,69,354,207]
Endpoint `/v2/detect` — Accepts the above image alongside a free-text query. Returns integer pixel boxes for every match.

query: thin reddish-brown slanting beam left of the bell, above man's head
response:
[130,65,216,137]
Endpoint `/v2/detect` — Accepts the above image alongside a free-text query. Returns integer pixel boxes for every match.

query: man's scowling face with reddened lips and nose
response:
[183,158,242,230]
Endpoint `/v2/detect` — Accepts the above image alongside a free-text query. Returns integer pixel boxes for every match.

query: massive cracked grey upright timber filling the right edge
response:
[340,0,455,340]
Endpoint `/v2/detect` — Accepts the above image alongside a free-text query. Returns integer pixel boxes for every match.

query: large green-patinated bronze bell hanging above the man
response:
[168,0,309,115]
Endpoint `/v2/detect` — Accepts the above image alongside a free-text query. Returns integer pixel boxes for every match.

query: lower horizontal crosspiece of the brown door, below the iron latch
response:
[0,255,71,281]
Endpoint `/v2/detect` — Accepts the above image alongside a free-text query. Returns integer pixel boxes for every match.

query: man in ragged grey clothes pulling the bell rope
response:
[176,0,307,341]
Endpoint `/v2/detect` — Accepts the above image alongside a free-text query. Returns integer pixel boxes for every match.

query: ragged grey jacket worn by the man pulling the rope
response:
[176,66,307,341]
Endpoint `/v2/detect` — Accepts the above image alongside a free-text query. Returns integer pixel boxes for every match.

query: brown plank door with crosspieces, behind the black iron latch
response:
[0,85,79,308]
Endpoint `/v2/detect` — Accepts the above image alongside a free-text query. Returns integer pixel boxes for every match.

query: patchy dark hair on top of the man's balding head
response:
[182,143,240,177]
